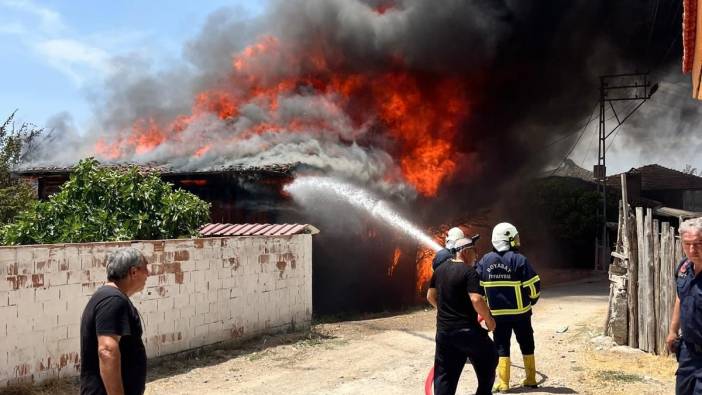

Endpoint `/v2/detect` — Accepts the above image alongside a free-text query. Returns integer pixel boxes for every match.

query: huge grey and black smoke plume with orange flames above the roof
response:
[29,0,688,203]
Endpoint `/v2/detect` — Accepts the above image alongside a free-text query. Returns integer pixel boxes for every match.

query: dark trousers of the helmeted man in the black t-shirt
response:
[434,328,497,395]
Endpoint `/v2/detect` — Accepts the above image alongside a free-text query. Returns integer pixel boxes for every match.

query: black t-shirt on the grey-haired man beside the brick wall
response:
[80,285,146,395]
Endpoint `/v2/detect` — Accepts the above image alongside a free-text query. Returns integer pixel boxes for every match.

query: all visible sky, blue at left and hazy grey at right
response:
[0,0,702,174]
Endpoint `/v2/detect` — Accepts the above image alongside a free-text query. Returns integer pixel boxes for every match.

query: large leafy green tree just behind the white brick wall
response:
[0,158,210,244]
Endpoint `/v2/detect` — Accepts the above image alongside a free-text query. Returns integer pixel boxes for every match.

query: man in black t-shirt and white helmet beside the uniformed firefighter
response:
[427,238,497,395]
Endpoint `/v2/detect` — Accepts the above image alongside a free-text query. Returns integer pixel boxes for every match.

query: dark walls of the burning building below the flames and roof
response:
[15,165,431,314]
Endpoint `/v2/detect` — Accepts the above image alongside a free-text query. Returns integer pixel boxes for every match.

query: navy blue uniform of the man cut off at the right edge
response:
[675,259,702,395]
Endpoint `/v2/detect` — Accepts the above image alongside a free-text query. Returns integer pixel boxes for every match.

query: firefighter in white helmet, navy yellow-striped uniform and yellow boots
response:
[476,222,541,392]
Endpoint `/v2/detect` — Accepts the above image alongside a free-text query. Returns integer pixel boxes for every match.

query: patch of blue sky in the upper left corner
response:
[0,0,265,129]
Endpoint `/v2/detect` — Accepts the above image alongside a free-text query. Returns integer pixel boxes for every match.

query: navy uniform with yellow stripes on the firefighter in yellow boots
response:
[476,250,541,357]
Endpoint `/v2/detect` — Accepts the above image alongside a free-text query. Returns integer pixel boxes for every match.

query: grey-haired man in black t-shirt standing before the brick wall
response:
[80,248,149,395]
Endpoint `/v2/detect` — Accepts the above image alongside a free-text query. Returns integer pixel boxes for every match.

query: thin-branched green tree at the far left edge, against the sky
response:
[0,112,43,226]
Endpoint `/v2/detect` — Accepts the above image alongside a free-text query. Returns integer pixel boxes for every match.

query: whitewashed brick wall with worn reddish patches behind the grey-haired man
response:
[0,234,312,388]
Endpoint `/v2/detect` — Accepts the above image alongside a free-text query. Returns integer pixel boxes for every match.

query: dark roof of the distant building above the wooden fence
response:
[607,165,702,191]
